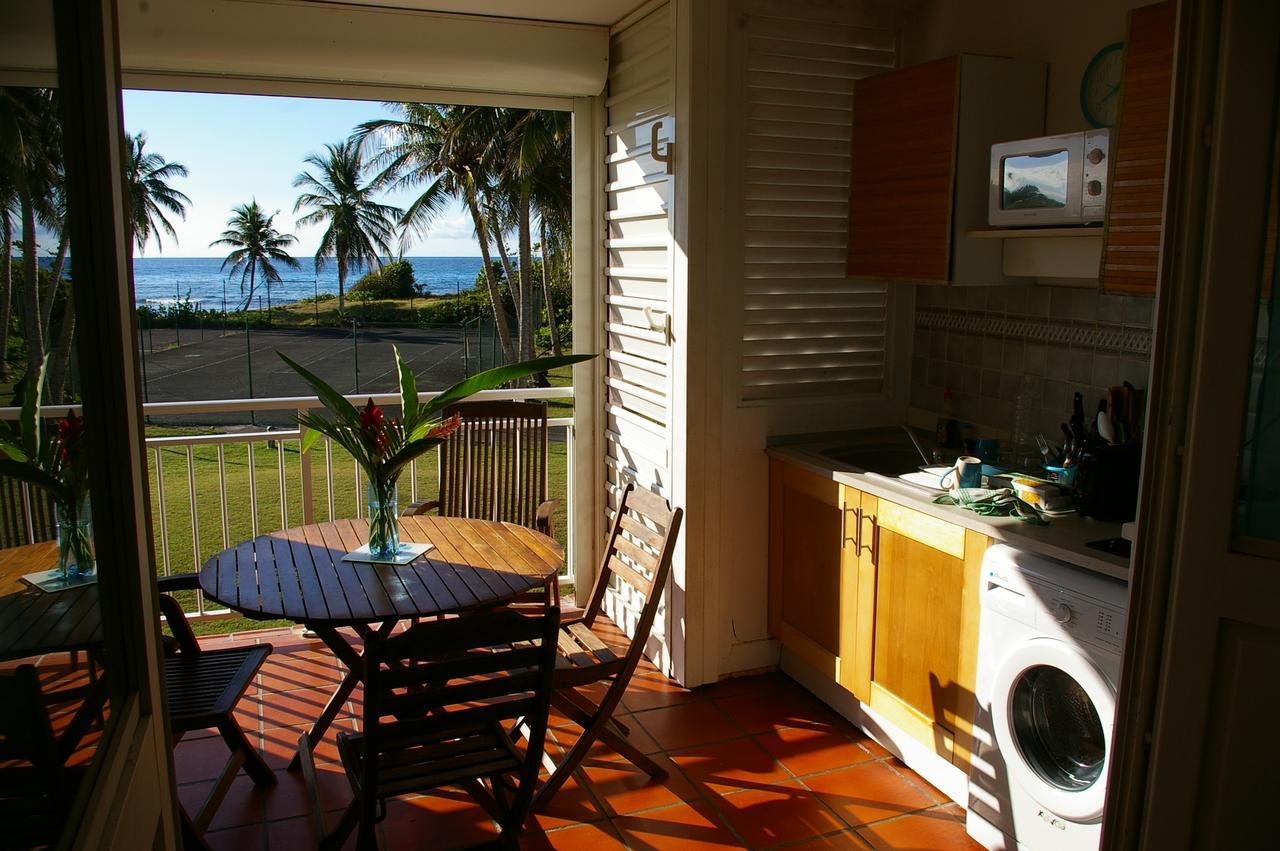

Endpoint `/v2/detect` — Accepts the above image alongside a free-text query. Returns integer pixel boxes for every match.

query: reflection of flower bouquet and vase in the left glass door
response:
[0,365,96,581]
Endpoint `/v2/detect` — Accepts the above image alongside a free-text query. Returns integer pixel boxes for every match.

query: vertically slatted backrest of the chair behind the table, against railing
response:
[439,402,548,526]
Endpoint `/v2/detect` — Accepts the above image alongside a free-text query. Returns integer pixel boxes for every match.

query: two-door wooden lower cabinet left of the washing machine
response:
[769,461,988,772]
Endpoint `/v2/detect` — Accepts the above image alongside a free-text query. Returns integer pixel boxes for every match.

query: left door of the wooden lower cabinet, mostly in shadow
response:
[769,461,876,700]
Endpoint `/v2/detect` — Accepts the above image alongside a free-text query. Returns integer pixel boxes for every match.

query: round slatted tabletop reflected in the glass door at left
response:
[0,541,102,660]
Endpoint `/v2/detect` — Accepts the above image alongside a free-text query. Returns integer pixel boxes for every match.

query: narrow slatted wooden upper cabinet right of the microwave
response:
[1102,0,1176,294]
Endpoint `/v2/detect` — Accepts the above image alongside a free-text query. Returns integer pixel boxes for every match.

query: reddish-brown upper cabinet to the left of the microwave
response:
[846,55,1046,285]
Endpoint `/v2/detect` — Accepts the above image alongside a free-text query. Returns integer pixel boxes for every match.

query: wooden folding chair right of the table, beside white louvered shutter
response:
[534,485,684,810]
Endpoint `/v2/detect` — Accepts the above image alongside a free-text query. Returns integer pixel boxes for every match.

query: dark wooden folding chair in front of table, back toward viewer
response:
[298,607,559,851]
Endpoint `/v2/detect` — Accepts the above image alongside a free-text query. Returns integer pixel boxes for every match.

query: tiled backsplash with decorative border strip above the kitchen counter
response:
[911,285,1153,450]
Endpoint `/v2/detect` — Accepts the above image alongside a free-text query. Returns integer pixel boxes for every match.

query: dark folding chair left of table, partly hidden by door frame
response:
[159,573,275,848]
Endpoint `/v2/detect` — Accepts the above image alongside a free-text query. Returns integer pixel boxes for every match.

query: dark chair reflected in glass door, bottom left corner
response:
[0,665,84,848]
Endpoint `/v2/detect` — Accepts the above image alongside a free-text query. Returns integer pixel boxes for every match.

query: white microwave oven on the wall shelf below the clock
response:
[987,128,1110,228]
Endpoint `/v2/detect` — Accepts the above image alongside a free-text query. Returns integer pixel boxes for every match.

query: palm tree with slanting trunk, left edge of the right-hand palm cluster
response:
[352,104,516,363]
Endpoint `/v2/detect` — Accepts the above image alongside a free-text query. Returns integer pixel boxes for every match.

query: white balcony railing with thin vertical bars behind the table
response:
[0,388,573,617]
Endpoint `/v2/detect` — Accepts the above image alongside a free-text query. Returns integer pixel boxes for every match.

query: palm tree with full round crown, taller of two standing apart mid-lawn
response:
[293,139,401,314]
